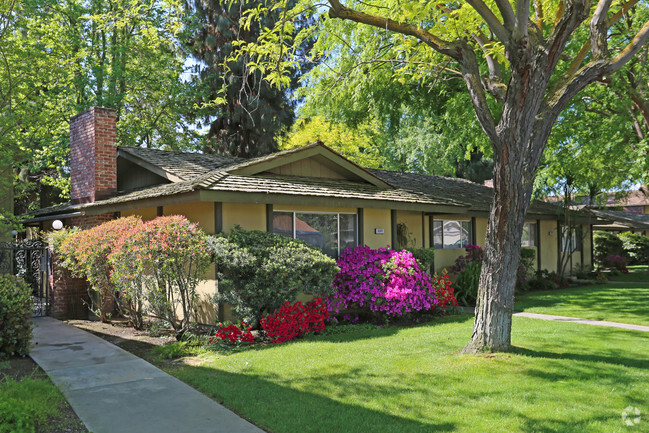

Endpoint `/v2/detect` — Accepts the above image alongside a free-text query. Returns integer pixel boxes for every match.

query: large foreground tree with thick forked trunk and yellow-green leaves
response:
[230,0,649,353]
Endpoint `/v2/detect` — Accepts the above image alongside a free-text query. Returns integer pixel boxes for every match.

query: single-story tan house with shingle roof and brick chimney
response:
[28,108,595,321]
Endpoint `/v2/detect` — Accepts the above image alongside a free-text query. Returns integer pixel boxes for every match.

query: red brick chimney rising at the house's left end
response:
[70,107,117,204]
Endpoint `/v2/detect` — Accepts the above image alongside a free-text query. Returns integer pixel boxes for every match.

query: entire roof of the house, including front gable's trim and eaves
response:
[29,143,561,218]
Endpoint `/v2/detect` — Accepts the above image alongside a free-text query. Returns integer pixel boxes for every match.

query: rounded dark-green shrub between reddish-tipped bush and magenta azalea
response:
[211,227,338,326]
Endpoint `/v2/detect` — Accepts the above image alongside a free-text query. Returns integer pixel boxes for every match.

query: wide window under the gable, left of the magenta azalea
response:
[273,212,358,257]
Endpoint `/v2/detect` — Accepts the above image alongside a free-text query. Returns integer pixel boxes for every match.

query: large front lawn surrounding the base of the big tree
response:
[170,316,649,433]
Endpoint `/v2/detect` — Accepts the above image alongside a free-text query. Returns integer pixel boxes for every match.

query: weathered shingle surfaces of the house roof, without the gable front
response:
[37,145,559,215]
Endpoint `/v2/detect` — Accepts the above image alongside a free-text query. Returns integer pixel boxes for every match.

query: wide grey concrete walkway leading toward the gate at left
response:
[30,317,263,433]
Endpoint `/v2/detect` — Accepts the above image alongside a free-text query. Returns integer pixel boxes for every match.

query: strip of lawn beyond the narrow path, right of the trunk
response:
[514,281,649,325]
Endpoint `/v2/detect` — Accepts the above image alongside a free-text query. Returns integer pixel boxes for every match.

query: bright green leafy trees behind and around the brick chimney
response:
[0,0,198,212]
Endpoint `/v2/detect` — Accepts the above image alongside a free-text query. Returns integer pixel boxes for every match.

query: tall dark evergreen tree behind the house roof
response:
[189,0,295,157]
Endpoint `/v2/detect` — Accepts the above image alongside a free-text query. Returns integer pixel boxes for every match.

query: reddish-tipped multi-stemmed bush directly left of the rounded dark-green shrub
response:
[109,215,211,337]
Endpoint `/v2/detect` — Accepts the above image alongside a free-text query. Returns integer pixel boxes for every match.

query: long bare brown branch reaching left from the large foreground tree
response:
[329,0,461,61]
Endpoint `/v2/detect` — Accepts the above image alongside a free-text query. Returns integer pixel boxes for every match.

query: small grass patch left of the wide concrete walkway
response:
[0,361,69,433]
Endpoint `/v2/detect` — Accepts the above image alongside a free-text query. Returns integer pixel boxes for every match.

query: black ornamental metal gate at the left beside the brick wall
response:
[0,240,50,316]
